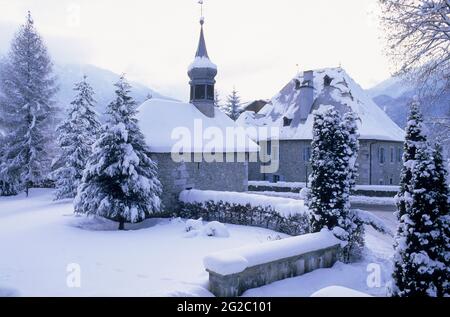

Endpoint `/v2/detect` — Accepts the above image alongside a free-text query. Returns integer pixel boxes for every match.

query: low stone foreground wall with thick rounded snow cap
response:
[204,230,342,297]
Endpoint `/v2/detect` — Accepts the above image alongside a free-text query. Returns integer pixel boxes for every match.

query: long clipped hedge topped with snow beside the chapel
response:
[178,190,309,235]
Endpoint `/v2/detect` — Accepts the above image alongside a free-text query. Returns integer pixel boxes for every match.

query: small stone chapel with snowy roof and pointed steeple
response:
[137,18,259,212]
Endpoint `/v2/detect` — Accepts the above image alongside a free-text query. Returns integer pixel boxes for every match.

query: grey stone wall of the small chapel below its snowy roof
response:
[151,153,248,213]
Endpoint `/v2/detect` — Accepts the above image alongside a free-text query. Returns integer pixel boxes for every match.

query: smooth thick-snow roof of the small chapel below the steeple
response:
[137,99,259,153]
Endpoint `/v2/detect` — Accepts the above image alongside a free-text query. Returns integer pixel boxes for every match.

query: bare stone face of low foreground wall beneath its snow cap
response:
[208,245,340,297]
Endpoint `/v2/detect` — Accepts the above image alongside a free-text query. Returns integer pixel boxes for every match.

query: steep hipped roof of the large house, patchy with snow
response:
[237,67,404,141]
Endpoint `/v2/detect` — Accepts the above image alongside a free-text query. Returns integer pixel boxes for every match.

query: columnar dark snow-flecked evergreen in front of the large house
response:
[307,107,359,262]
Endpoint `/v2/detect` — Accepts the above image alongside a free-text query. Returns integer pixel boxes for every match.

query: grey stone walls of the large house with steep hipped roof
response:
[249,140,403,185]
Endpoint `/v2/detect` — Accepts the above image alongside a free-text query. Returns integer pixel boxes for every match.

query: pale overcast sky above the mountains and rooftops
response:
[0,0,390,100]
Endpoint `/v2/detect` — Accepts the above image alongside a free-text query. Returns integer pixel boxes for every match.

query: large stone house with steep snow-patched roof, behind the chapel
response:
[238,67,404,185]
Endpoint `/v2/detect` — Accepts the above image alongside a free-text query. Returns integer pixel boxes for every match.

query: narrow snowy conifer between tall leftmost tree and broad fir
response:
[52,76,100,200]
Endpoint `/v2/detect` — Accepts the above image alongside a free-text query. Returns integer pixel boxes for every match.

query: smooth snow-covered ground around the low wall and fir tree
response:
[0,189,395,296]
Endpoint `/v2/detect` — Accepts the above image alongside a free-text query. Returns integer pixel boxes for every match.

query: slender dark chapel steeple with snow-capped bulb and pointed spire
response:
[188,7,217,118]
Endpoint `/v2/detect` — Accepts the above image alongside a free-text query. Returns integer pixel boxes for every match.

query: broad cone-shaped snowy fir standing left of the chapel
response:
[74,76,162,230]
